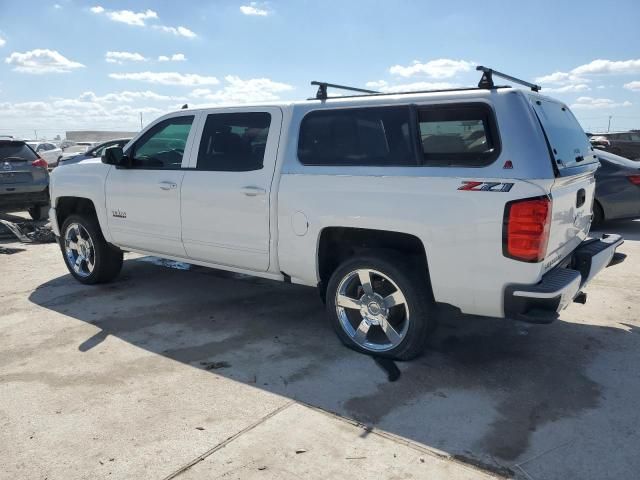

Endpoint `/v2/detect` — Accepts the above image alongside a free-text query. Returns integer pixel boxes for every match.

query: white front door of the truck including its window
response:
[106,113,194,257]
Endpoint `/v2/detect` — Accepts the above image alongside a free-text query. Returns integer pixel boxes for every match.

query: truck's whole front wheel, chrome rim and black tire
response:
[60,214,122,285]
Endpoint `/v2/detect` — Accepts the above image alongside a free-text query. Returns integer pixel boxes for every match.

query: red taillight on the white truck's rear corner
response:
[502,197,551,262]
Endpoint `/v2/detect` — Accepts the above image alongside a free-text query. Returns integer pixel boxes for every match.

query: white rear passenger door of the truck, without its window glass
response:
[181,107,282,271]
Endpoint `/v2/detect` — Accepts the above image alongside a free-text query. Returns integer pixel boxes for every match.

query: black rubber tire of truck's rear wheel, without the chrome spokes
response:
[326,251,436,360]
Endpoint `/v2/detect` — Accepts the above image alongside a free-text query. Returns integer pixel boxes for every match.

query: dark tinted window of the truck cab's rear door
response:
[196,112,271,172]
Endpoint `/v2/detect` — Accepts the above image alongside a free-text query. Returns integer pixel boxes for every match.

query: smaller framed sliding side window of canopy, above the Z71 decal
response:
[418,105,499,167]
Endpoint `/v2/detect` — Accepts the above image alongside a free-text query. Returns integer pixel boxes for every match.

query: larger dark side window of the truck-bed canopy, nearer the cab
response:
[298,107,416,166]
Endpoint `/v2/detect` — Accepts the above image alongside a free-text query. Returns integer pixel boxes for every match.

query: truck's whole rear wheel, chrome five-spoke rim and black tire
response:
[327,252,435,360]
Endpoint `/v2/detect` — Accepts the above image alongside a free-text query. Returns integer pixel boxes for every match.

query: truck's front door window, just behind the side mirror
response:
[131,115,194,170]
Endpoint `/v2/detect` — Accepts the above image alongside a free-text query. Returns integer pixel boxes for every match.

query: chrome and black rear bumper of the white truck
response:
[504,235,624,323]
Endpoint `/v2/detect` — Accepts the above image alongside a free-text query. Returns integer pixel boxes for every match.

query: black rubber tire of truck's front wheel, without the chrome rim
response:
[60,213,122,285]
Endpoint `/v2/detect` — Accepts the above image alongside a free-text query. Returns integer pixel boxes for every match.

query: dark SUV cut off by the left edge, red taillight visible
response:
[0,138,49,220]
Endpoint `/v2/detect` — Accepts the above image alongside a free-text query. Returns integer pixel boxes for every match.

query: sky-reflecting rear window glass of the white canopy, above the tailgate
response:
[533,99,598,170]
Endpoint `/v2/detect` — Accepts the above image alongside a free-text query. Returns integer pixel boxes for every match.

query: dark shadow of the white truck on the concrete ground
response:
[30,248,640,476]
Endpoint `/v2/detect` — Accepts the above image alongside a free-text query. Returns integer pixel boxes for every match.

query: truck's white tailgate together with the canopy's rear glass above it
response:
[532,97,598,267]
